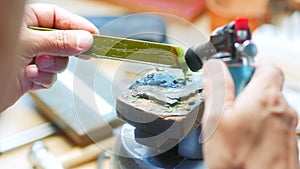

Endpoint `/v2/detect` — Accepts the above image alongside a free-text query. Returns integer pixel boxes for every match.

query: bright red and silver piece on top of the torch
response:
[234,18,250,43]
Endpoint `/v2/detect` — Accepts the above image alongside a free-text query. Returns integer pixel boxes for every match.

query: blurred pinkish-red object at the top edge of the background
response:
[98,0,205,21]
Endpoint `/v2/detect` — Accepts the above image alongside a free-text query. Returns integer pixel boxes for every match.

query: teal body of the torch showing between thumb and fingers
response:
[228,66,254,96]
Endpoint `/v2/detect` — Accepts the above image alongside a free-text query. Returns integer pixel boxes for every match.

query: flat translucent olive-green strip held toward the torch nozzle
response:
[30,27,188,73]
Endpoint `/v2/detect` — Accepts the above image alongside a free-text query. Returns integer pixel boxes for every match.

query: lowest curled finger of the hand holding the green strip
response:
[25,65,56,90]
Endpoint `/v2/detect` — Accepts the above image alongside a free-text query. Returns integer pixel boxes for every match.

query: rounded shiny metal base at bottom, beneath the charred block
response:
[112,124,207,169]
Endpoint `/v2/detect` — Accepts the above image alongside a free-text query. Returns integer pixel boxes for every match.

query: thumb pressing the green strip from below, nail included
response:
[30,30,93,56]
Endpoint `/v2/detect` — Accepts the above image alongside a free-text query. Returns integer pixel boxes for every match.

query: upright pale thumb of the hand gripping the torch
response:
[202,60,235,141]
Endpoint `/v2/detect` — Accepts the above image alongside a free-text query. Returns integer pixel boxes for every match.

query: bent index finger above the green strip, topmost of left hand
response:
[24,4,99,34]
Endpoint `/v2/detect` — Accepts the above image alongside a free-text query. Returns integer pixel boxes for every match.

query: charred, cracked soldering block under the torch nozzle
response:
[116,71,204,146]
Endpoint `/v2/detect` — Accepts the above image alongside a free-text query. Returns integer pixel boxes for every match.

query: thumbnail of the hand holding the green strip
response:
[77,31,93,53]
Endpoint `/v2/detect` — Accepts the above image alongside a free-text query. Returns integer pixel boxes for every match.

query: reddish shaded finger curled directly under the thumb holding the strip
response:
[35,55,69,73]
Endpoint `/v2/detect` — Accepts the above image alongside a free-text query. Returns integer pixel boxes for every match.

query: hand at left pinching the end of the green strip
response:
[0,4,98,110]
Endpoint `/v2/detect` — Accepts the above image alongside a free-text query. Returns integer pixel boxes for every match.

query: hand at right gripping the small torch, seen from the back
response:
[203,60,299,169]
